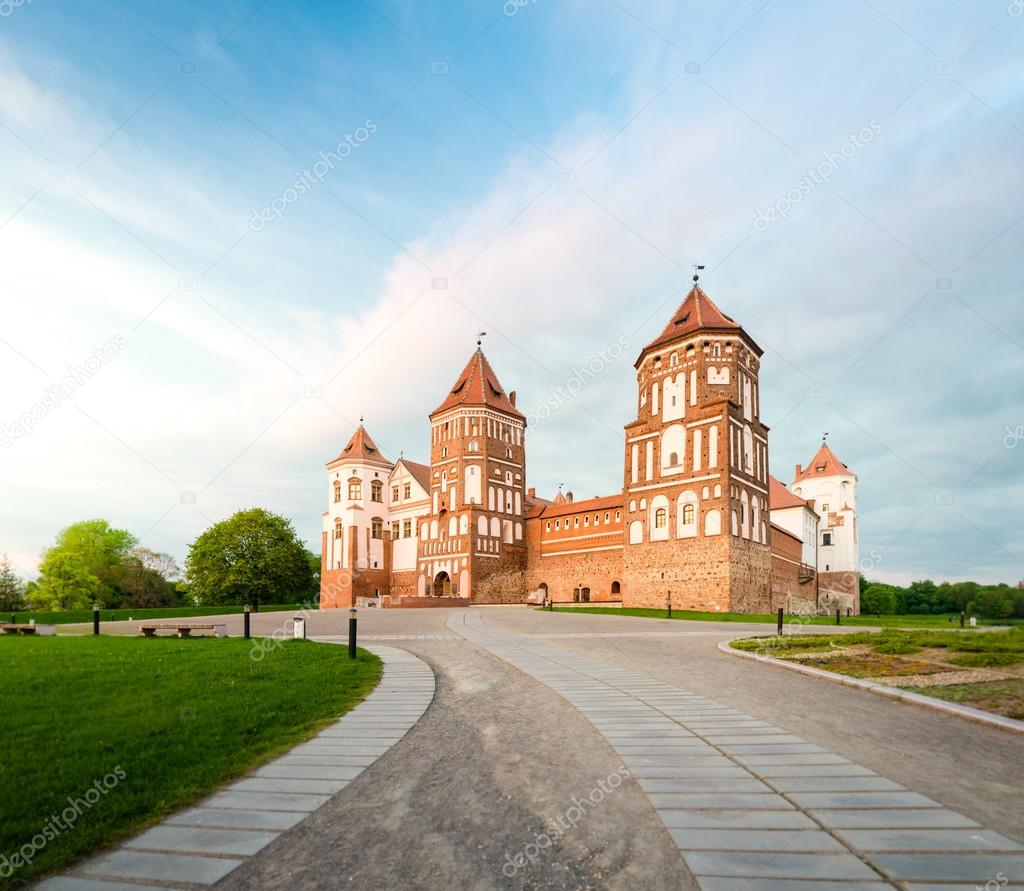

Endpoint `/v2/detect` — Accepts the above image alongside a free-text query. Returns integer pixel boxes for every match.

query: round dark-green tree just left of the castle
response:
[185,508,312,605]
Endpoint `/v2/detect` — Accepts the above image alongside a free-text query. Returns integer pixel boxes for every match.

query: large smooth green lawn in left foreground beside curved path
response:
[0,636,381,888]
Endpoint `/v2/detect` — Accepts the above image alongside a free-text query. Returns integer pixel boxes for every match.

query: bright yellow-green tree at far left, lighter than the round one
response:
[31,519,135,609]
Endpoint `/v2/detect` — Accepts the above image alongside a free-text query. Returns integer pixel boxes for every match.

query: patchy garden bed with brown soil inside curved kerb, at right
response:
[731,626,1024,720]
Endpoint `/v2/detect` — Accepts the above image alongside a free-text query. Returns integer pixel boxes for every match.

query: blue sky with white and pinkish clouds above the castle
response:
[0,0,1024,584]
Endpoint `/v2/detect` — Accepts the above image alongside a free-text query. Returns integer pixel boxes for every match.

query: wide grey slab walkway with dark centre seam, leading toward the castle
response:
[449,610,1024,891]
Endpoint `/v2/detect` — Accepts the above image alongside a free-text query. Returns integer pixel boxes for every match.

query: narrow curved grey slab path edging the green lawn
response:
[38,646,434,891]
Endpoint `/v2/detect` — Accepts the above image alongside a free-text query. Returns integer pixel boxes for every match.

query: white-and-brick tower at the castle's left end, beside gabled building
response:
[321,420,394,609]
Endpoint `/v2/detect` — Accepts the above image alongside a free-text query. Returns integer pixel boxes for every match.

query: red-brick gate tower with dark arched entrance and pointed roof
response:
[417,348,526,603]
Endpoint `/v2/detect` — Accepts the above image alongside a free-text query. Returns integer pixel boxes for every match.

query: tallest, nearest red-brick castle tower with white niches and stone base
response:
[624,286,771,612]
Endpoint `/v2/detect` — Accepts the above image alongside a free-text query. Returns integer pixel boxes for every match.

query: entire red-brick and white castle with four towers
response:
[321,285,859,613]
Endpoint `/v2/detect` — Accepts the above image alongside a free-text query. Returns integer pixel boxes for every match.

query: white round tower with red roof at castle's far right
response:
[791,440,860,613]
